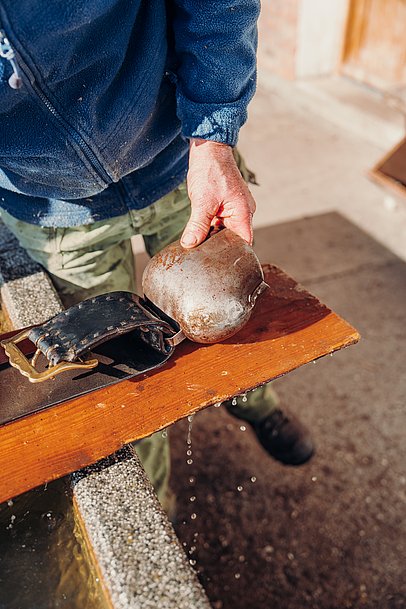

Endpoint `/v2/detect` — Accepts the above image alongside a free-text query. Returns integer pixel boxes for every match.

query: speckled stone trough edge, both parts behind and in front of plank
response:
[0,223,210,609]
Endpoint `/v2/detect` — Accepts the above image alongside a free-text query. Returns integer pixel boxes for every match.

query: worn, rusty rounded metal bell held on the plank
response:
[142,229,267,343]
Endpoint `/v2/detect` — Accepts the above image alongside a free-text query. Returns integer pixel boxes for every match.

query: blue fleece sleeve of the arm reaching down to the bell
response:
[173,0,260,146]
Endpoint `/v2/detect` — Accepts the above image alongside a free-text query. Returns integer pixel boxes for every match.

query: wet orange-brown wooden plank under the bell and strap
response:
[0,265,359,501]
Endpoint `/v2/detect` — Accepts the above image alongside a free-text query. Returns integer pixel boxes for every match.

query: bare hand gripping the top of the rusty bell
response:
[181,140,255,248]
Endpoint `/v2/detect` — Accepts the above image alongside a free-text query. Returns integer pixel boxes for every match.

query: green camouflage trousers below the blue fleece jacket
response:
[1,179,276,508]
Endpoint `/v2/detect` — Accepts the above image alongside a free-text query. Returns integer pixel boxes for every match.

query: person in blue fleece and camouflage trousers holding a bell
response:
[0,0,313,505]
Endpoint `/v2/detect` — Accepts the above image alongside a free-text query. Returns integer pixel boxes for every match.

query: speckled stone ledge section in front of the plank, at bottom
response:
[72,446,210,609]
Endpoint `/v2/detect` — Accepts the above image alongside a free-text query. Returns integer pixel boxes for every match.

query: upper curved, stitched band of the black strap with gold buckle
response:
[2,292,184,382]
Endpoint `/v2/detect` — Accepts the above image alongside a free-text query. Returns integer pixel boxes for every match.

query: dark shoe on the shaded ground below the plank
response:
[251,408,314,465]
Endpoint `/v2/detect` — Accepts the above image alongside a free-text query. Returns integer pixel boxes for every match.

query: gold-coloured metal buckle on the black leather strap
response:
[0,328,99,383]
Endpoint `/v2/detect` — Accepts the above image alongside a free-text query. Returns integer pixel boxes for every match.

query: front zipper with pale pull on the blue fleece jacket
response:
[0,30,111,184]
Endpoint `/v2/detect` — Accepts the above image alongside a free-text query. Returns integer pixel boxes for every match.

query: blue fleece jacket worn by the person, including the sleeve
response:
[0,0,259,226]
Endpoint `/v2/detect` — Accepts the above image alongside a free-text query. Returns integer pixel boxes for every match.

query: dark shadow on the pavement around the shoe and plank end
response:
[172,213,406,609]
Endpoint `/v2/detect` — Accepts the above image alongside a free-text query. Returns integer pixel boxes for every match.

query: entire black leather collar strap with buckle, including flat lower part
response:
[0,292,183,426]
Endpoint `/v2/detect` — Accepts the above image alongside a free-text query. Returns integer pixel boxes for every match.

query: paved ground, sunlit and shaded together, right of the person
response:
[167,66,406,609]
